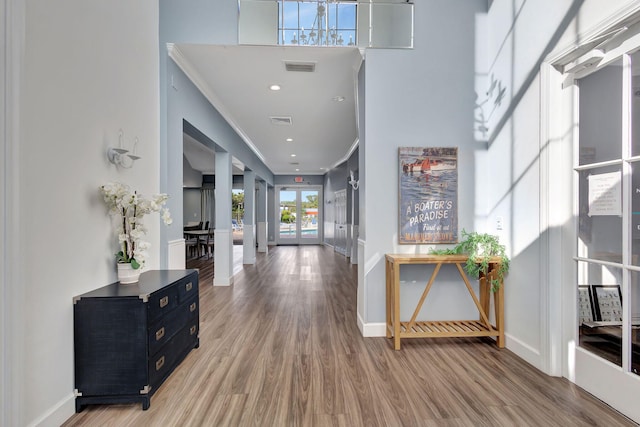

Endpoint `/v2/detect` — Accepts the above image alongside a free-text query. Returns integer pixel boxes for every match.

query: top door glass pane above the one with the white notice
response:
[579,60,623,165]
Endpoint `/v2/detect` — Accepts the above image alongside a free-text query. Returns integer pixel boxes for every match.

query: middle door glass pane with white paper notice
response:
[578,166,622,263]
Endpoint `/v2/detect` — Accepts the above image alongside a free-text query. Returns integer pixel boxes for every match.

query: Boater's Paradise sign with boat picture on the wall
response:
[398,147,458,244]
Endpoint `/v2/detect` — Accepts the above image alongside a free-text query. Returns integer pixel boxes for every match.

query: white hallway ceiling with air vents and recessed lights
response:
[171,44,362,175]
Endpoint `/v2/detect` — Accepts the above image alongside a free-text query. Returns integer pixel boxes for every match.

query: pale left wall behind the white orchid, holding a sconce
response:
[12,0,161,426]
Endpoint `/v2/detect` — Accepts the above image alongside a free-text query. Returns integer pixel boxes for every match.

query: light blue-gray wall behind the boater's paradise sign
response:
[358,0,487,324]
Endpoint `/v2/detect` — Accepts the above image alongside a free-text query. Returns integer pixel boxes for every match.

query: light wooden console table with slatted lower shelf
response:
[385,254,505,350]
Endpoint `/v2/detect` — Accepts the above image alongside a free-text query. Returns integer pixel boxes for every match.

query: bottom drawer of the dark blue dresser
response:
[149,318,199,391]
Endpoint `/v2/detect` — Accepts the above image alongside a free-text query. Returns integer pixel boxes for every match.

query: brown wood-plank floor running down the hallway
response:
[64,246,636,427]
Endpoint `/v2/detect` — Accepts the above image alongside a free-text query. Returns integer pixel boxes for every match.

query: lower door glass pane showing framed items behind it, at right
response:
[577,262,622,366]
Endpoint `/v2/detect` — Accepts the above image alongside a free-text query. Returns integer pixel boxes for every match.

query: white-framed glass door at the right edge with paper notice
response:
[569,43,640,414]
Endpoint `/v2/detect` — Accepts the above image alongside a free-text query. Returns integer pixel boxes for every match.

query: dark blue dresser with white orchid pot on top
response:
[73,270,200,412]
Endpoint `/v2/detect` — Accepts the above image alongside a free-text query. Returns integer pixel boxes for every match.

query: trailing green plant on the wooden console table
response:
[431,229,509,292]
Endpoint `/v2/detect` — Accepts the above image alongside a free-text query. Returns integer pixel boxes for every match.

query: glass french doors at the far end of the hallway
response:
[275,186,322,245]
